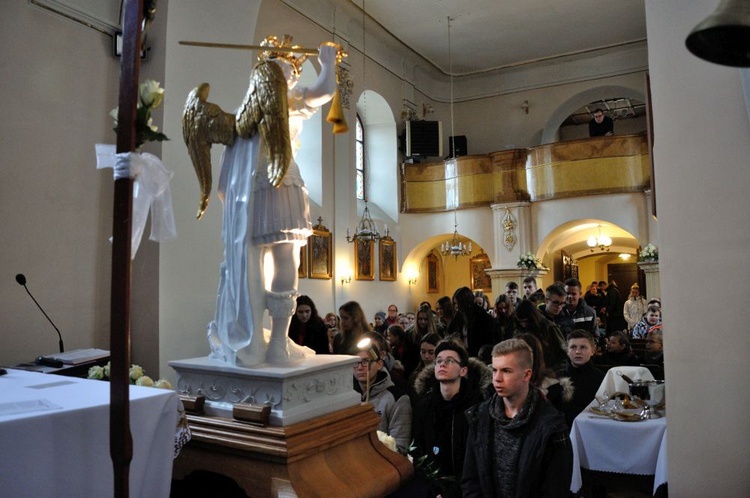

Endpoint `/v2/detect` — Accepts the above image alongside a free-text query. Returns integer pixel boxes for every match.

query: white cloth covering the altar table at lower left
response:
[0,369,179,498]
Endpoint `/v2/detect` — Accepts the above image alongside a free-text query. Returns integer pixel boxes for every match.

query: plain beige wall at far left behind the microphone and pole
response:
[0,1,168,374]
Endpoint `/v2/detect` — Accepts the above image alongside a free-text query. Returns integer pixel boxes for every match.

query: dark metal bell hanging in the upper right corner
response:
[685,0,750,67]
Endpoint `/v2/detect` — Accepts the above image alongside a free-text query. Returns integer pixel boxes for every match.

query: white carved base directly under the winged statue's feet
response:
[169,355,360,426]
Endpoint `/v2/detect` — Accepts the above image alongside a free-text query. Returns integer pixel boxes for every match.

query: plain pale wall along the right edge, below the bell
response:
[646,0,750,497]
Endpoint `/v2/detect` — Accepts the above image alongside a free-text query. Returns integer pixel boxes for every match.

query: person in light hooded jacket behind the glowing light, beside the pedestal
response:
[354,332,411,452]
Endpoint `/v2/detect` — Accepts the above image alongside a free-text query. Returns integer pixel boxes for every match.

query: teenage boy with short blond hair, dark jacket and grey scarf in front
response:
[461,339,573,498]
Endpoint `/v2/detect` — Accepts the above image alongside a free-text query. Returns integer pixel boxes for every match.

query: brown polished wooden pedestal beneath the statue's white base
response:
[173,403,413,498]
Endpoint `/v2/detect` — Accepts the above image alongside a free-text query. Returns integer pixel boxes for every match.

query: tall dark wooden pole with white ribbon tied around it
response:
[109,0,143,498]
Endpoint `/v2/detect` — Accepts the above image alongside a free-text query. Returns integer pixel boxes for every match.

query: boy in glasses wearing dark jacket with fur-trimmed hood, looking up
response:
[411,339,492,498]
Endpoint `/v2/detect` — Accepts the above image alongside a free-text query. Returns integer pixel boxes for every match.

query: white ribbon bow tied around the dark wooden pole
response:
[95,144,177,259]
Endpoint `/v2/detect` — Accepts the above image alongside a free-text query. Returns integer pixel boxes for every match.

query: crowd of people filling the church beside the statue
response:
[289,277,663,497]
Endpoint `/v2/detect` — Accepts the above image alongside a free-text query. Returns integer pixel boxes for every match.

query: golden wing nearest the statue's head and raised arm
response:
[236,61,292,187]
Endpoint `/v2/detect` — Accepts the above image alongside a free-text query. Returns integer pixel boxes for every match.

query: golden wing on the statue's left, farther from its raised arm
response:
[182,83,235,220]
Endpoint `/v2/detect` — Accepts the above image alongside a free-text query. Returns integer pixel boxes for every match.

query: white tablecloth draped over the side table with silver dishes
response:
[570,403,668,493]
